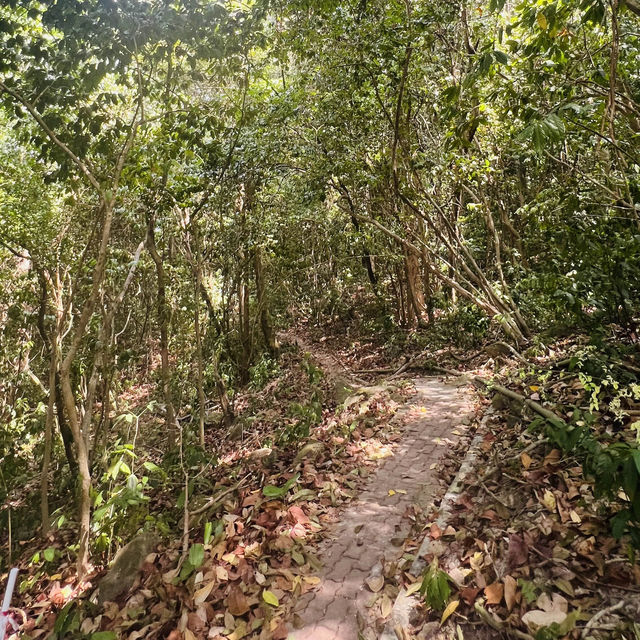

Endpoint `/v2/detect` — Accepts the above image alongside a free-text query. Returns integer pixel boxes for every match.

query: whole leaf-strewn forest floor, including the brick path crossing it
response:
[6,332,640,640]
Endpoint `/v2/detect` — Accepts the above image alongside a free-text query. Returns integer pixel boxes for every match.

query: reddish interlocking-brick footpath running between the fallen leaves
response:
[289,378,472,640]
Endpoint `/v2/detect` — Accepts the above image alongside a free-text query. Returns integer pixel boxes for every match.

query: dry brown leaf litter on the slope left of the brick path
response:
[10,344,412,640]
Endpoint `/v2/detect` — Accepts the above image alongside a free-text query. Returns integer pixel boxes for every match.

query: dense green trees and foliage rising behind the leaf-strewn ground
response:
[0,0,640,616]
